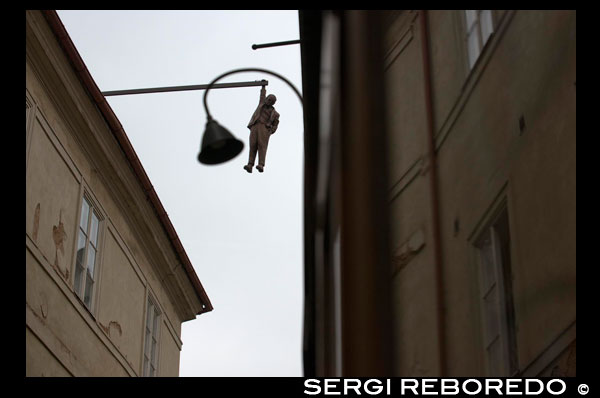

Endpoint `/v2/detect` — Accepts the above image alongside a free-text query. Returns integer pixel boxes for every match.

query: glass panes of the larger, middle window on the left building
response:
[73,195,101,311]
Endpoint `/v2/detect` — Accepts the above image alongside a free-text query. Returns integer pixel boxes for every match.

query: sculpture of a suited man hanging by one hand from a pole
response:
[244,82,279,173]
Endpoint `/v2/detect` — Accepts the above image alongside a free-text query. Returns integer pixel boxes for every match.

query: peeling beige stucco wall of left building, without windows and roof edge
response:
[26,11,190,376]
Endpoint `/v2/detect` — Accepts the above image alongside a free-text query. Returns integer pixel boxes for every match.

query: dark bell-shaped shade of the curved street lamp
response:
[198,119,244,164]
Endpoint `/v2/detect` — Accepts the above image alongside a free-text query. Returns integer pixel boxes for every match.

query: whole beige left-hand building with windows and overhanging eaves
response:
[25,11,213,376]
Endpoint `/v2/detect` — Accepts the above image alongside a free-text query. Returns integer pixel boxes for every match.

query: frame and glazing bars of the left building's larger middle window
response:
[71,188,106,315]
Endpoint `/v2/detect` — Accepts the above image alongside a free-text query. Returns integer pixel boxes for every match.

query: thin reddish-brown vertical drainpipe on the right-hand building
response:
[419,10,447,377]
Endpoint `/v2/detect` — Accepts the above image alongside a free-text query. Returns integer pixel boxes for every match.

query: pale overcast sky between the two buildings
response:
[58,10,303,376]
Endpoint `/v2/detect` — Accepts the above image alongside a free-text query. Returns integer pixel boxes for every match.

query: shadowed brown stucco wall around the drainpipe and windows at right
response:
[386,11,576,376]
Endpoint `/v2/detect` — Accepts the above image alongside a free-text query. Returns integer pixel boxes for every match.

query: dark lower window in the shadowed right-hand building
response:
[475,208,518,376]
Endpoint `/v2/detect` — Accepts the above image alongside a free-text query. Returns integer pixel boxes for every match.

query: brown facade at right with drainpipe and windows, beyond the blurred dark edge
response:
[384,10,576,377]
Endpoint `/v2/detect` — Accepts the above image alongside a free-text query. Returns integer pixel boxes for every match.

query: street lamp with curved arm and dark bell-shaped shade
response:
[198,68,303,165]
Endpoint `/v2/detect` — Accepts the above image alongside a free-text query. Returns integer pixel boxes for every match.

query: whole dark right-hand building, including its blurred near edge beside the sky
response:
[300,10,577,377]
